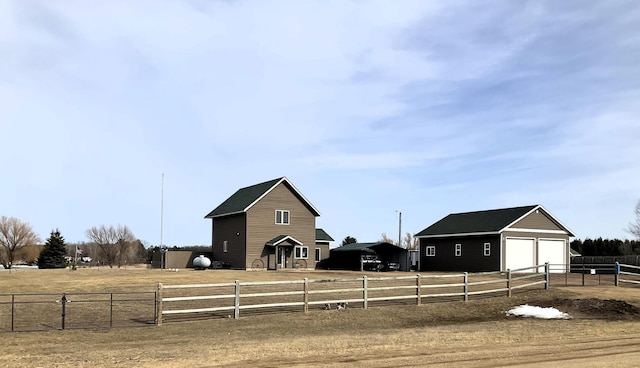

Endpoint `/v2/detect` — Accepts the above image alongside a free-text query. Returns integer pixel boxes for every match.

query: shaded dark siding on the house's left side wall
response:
[212,213,251,268]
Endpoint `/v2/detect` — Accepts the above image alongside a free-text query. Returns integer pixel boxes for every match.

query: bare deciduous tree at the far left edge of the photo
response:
[0,216,40,268]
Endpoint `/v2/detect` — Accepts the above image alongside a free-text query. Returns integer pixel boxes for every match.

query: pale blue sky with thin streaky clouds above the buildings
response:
[0,0,640,246]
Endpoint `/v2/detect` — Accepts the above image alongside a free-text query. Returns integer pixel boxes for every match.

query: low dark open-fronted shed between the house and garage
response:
[329,242,408,271]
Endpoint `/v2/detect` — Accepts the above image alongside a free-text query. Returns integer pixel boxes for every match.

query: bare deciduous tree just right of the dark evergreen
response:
[87,225,136,268]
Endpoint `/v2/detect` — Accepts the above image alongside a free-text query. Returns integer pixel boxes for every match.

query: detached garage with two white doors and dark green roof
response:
[416,205,574,272]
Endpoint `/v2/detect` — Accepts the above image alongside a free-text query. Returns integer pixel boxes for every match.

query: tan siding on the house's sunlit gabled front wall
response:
[246,183,316,267]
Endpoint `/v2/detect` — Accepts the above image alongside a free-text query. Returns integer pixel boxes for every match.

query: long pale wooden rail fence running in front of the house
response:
[157,264,549,326]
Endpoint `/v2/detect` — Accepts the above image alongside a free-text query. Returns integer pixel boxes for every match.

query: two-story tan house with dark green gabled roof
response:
[205,177,333,269]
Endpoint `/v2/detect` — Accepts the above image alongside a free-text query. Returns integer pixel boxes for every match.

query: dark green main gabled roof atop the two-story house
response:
[205,177,320,218]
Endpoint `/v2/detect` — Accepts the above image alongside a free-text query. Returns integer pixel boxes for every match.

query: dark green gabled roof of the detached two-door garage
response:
[416,205,573,238]
